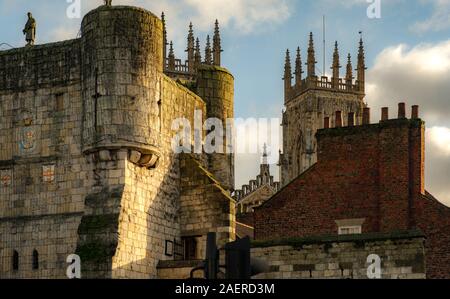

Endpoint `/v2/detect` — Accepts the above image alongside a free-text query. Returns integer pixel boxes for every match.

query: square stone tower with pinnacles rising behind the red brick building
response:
[279,33,366,186]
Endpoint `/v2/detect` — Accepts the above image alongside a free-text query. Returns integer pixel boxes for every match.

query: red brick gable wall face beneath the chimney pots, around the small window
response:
[255,120,418,239]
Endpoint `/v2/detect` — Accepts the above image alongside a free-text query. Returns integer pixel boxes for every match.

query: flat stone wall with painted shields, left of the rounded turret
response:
[0,40,85,278]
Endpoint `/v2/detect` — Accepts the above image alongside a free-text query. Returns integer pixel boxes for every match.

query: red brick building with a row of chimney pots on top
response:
[254,103,450,278]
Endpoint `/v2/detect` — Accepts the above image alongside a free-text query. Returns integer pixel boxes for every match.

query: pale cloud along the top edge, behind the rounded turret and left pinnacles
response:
[38,0,292,44]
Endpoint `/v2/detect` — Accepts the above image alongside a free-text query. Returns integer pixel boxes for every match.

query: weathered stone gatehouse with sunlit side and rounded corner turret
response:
[0,6,235,278]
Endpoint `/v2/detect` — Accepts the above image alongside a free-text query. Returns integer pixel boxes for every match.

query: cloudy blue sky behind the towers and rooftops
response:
[0,0,450,205]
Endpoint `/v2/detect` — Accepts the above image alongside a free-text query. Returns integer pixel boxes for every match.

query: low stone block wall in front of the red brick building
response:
[251,233,426,279]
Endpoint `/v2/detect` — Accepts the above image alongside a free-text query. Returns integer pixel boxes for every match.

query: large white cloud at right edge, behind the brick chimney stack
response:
[367,40,450,206]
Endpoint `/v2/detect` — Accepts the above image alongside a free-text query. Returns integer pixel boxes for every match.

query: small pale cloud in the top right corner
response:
[411,0,450,33]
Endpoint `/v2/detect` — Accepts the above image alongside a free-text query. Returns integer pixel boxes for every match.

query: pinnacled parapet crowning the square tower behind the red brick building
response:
[283,33,366,103]
